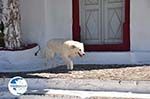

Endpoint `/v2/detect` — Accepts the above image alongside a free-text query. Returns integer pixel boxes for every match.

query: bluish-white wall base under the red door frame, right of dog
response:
[74,52,150,64]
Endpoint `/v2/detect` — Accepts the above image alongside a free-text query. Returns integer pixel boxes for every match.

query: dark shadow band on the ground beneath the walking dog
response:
[0,64,147,79]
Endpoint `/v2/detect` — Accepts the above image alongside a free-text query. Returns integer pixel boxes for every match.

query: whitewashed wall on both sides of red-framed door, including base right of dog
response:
[21,0,150,64]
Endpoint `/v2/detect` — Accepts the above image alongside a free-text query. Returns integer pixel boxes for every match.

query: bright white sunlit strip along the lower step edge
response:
[26,89,150,99]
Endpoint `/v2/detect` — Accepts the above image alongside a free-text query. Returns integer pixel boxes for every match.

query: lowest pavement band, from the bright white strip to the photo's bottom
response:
[0,89,150,99]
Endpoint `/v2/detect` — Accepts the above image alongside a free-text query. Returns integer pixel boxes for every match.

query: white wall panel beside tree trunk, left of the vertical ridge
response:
[20,0,45,44]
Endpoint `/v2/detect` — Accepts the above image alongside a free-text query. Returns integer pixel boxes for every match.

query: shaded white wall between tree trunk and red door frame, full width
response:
[21,0,72,45]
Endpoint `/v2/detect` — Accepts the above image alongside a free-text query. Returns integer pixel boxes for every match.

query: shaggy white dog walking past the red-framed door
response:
[36,39,85,70]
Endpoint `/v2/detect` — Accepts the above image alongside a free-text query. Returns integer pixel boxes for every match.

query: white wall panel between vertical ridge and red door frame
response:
[46,0,72,40]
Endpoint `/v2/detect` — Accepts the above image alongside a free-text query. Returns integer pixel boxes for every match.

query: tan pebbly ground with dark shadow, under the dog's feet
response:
[0,65,150,81]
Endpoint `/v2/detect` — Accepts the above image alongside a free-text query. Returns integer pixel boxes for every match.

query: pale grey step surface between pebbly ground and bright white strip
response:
[27,78,150,93]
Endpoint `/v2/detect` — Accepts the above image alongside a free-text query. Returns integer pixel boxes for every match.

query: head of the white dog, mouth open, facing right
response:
[71,41,85,57]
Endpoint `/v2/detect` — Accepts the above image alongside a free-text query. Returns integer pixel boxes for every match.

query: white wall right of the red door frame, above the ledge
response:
[130,0,150,51]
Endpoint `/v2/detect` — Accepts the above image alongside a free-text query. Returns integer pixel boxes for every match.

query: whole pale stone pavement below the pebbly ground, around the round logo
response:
[0,78,150,99]
